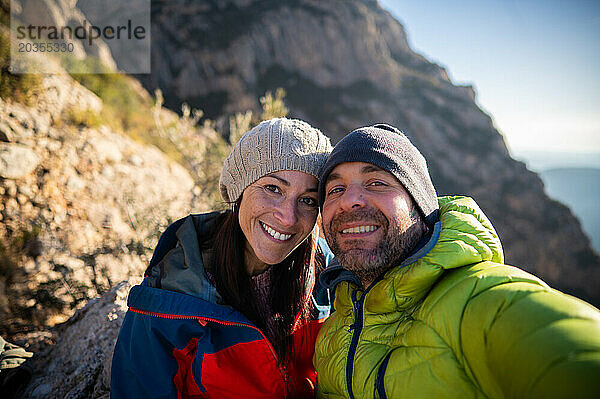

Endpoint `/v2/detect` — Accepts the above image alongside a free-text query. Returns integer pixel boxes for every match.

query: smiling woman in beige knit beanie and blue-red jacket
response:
[111,119,332,398]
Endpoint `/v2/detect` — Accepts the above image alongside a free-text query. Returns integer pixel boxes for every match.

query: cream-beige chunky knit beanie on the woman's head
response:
[219,118,332,203]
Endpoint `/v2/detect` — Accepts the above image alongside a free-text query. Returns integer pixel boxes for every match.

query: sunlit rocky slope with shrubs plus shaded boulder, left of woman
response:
[0,26,238,398]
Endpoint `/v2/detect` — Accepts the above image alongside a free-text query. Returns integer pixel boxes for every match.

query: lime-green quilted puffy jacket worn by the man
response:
[313,197,600,399]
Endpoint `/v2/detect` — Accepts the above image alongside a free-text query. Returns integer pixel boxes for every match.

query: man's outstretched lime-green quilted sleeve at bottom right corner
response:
[461,281,600,399]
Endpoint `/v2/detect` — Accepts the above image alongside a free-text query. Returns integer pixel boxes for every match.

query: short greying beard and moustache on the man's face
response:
[324,205,424,288]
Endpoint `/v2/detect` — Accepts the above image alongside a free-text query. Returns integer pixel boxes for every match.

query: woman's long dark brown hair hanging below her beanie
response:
[210,198,324,364]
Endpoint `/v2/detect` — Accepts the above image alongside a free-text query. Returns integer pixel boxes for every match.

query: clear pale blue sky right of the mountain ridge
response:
[379,0,600,153]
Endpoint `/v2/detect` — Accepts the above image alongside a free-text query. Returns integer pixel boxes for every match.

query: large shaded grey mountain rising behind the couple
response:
[141,0,600,305]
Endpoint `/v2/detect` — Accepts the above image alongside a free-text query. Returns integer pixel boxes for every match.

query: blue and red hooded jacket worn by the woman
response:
[111,213,332,399]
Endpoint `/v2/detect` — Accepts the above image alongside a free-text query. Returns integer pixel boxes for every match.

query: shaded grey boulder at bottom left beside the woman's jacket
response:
[23,281,135,399]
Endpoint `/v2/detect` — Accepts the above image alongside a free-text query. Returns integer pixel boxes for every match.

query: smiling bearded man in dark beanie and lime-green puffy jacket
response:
[313,124,600,399]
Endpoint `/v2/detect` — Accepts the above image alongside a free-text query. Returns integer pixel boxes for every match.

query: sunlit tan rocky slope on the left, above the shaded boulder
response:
[0,69,194,337]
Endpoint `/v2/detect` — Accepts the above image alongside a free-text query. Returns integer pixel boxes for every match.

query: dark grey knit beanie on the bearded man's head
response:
[319,124,438,226]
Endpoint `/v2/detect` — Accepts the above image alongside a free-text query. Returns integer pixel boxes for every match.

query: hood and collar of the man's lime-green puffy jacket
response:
[322,196,504,313]
